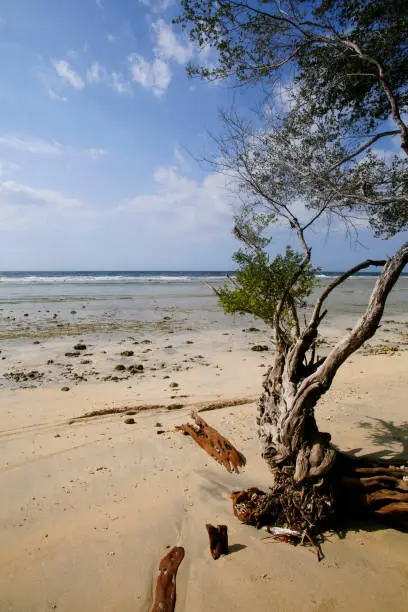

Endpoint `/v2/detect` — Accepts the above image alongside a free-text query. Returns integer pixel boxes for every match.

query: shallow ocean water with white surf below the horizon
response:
[0,270,408,339]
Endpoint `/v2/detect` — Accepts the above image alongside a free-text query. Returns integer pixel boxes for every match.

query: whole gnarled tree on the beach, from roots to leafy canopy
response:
[178,0,408,531]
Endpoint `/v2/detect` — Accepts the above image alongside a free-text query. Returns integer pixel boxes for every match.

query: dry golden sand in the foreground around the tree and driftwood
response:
[0,336,408,612]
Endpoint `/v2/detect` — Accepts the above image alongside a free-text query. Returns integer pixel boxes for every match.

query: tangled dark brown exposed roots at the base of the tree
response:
[232,454,408,537]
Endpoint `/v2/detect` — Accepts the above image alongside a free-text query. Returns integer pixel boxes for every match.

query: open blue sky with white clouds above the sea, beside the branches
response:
[0,0,401,270]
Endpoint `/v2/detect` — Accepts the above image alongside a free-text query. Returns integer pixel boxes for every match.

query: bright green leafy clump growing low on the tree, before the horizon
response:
[218,213,317,331]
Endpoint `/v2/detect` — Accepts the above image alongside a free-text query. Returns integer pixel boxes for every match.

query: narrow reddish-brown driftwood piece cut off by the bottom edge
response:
[151,546,184,612]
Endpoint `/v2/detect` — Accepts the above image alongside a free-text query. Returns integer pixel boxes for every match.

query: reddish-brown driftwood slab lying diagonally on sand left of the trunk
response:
[176,414,246,473]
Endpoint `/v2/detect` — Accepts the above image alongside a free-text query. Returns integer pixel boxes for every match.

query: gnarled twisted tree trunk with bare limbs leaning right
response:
[258,243,408,522]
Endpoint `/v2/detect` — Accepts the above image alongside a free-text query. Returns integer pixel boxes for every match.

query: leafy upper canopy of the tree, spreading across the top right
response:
[177,0,408,237]
